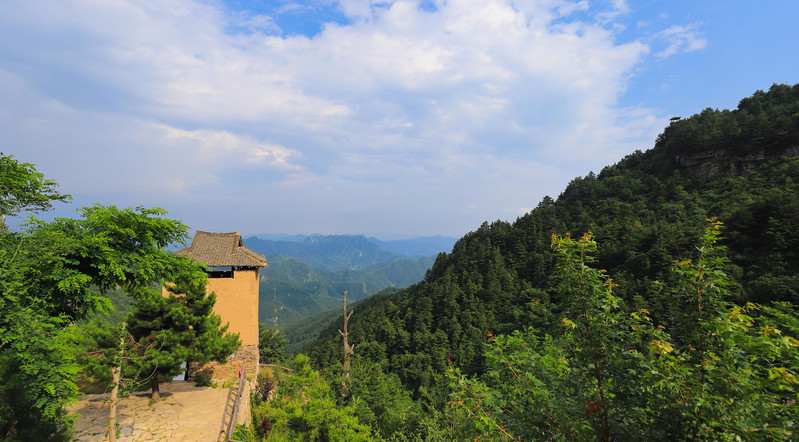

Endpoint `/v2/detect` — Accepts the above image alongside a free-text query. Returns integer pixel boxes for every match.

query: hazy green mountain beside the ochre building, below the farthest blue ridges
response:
[258,255,435,329]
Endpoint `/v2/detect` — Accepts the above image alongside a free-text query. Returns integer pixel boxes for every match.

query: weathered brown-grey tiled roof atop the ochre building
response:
[175,230,266,267]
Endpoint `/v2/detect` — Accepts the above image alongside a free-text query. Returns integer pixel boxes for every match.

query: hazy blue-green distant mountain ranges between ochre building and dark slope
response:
[244,234,455,328]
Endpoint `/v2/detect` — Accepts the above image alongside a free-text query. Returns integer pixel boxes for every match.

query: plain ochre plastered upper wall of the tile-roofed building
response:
[208,269,258,346]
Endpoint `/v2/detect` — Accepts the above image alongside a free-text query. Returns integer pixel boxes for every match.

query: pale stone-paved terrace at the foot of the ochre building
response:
[69,381,235,442]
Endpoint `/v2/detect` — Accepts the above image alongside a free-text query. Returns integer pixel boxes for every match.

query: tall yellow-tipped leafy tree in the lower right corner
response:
[643,219,799,440]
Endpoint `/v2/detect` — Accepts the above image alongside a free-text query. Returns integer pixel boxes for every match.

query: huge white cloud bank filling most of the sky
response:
[0,0,688,233]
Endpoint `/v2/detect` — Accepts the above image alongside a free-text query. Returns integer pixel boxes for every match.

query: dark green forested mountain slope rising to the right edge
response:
[309,85,799,404]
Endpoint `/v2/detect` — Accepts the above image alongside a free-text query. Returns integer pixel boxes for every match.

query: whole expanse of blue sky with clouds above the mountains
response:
[0,0,799,238]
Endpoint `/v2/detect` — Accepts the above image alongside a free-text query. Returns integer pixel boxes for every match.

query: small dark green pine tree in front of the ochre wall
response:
[128,276,241,401]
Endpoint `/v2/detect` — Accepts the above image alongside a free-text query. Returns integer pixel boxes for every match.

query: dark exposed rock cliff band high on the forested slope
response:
[674,146,799,178]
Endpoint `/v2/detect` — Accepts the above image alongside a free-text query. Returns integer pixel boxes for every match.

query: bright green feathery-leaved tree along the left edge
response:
[0,156,201,440]
